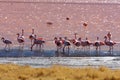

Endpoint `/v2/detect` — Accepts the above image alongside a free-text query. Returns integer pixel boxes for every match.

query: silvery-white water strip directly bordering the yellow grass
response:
[0,57,120,69]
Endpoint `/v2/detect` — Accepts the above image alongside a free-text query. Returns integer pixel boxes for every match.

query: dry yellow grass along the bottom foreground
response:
[0,64,120,80]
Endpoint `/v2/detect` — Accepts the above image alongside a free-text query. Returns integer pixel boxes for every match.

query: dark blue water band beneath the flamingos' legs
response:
[0,49,120,57]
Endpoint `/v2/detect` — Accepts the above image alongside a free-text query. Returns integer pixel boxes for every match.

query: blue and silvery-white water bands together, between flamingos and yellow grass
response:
[0,46,120,69]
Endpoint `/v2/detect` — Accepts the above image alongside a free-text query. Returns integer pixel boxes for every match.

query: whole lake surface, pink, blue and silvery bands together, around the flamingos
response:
[0,0,120,69]
